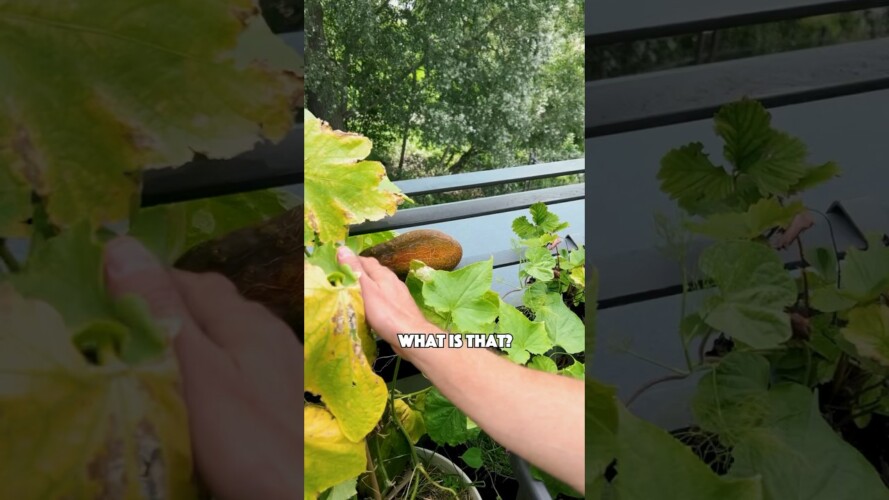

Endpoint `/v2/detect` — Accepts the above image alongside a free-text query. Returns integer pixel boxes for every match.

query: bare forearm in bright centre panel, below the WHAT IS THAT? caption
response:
[415,348,584,492]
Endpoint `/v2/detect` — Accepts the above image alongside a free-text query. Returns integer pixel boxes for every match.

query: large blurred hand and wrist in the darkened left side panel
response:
[105,238,303,499]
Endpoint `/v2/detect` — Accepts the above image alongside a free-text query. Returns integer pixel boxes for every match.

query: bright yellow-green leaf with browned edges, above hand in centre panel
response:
[304,111,407,243]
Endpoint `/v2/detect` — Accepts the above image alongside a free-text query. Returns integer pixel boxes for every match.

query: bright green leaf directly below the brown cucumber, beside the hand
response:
[422,258,500,333]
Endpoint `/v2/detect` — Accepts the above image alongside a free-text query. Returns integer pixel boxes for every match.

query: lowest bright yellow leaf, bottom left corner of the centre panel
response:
[303,406,366,499]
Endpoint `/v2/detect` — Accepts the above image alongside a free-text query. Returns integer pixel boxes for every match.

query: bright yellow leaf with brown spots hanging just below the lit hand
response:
[304,262,387,442]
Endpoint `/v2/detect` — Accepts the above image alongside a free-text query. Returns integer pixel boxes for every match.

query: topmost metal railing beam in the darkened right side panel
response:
[585,0,889,47]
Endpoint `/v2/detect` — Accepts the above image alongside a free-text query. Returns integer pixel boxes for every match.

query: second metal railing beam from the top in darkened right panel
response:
[585,38,889,138]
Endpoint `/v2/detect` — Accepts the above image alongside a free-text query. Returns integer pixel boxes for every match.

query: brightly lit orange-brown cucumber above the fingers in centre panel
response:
[361,229,463,278]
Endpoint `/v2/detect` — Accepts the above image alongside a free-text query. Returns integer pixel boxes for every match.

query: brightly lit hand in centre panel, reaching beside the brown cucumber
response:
[337,246,441,361]
